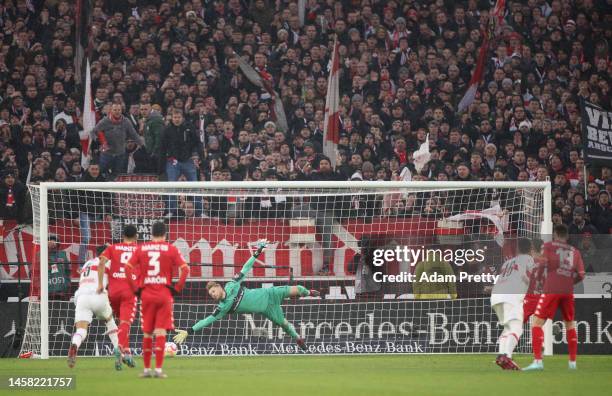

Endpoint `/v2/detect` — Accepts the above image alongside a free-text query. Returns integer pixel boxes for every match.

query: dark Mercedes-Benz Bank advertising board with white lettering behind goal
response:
[34,299,612,356]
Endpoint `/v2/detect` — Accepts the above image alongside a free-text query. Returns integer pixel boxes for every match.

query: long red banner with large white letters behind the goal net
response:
[0,218,435,279]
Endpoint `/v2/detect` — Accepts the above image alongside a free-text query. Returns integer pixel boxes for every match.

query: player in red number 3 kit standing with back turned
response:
[125,222,189,378]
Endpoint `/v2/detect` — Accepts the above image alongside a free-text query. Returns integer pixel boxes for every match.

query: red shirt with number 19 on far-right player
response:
[542,241,584,294]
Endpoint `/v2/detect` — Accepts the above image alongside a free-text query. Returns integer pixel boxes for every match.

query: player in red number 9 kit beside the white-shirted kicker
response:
[98,225,138,370]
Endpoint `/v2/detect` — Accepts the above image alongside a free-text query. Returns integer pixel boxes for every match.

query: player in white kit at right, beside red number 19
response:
[491,238,535,370]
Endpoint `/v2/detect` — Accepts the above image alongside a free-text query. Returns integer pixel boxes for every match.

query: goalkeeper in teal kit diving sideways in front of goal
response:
[174,240,320,351]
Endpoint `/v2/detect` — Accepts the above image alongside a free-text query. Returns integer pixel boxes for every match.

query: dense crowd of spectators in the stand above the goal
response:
[0,0,612,233]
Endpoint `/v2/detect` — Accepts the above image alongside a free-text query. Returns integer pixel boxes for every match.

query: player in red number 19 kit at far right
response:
[523,224,584,371]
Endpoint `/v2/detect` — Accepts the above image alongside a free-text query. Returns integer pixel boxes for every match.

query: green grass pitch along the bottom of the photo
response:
[0,355,612,396]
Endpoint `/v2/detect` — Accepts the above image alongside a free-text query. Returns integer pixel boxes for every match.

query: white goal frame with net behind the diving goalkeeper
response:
[22,182,552,358]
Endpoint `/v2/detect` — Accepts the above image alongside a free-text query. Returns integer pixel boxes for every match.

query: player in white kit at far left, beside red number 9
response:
[68,251,121,370]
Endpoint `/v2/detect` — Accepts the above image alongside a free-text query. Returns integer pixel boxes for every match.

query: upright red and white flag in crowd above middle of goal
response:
[323,39,340,168]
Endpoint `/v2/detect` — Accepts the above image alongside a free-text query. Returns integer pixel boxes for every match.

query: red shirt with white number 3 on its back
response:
[130,242,187,295]
